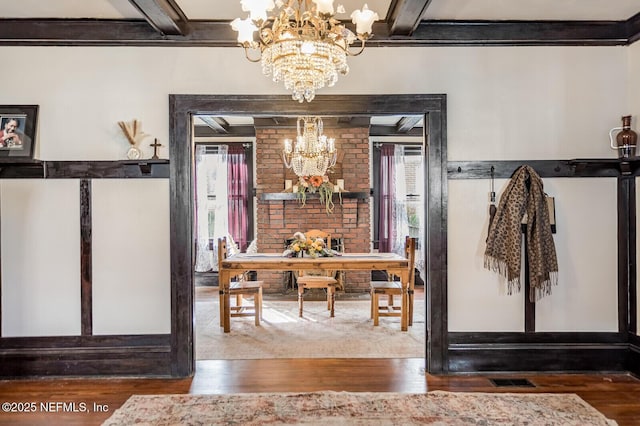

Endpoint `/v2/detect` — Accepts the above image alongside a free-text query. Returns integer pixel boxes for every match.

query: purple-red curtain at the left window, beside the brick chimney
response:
[227,144,249,252]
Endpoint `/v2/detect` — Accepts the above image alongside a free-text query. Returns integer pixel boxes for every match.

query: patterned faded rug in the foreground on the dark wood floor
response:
[103,391,616,426]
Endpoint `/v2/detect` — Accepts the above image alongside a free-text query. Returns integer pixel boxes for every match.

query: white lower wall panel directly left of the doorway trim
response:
[91,179,171,334]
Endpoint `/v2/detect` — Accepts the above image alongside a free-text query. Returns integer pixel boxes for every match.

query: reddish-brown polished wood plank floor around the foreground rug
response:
[0,359,640,426]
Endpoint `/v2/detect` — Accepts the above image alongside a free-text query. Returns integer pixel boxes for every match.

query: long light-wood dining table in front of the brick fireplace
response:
[218,253,409,333]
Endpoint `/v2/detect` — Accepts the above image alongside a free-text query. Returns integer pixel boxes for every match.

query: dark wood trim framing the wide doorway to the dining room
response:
[169,94,448,377]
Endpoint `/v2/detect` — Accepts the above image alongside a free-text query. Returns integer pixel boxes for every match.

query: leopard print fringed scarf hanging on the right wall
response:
[484,166,558,302]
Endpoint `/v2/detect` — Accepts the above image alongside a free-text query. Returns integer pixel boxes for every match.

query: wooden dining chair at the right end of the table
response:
[370,237,416,326]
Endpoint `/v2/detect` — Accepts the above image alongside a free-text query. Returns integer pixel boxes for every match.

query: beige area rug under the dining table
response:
[195,287,426,360]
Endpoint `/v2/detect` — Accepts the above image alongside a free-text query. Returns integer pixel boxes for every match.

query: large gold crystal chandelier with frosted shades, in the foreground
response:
[231,0,379,102]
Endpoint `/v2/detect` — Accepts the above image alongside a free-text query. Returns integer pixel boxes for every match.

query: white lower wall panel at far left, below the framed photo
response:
[0,179,81,337]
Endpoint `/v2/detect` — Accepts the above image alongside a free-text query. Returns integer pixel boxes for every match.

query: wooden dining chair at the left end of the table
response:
[218,238,264,327]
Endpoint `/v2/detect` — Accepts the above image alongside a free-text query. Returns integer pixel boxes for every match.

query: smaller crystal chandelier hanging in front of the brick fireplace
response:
[282,117,337,177]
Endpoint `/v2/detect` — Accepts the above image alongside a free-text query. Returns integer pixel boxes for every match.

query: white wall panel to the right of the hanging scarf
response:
[536,178,618,332]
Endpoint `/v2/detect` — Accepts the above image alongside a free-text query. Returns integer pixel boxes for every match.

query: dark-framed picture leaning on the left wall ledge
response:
[0,105,38,162]
